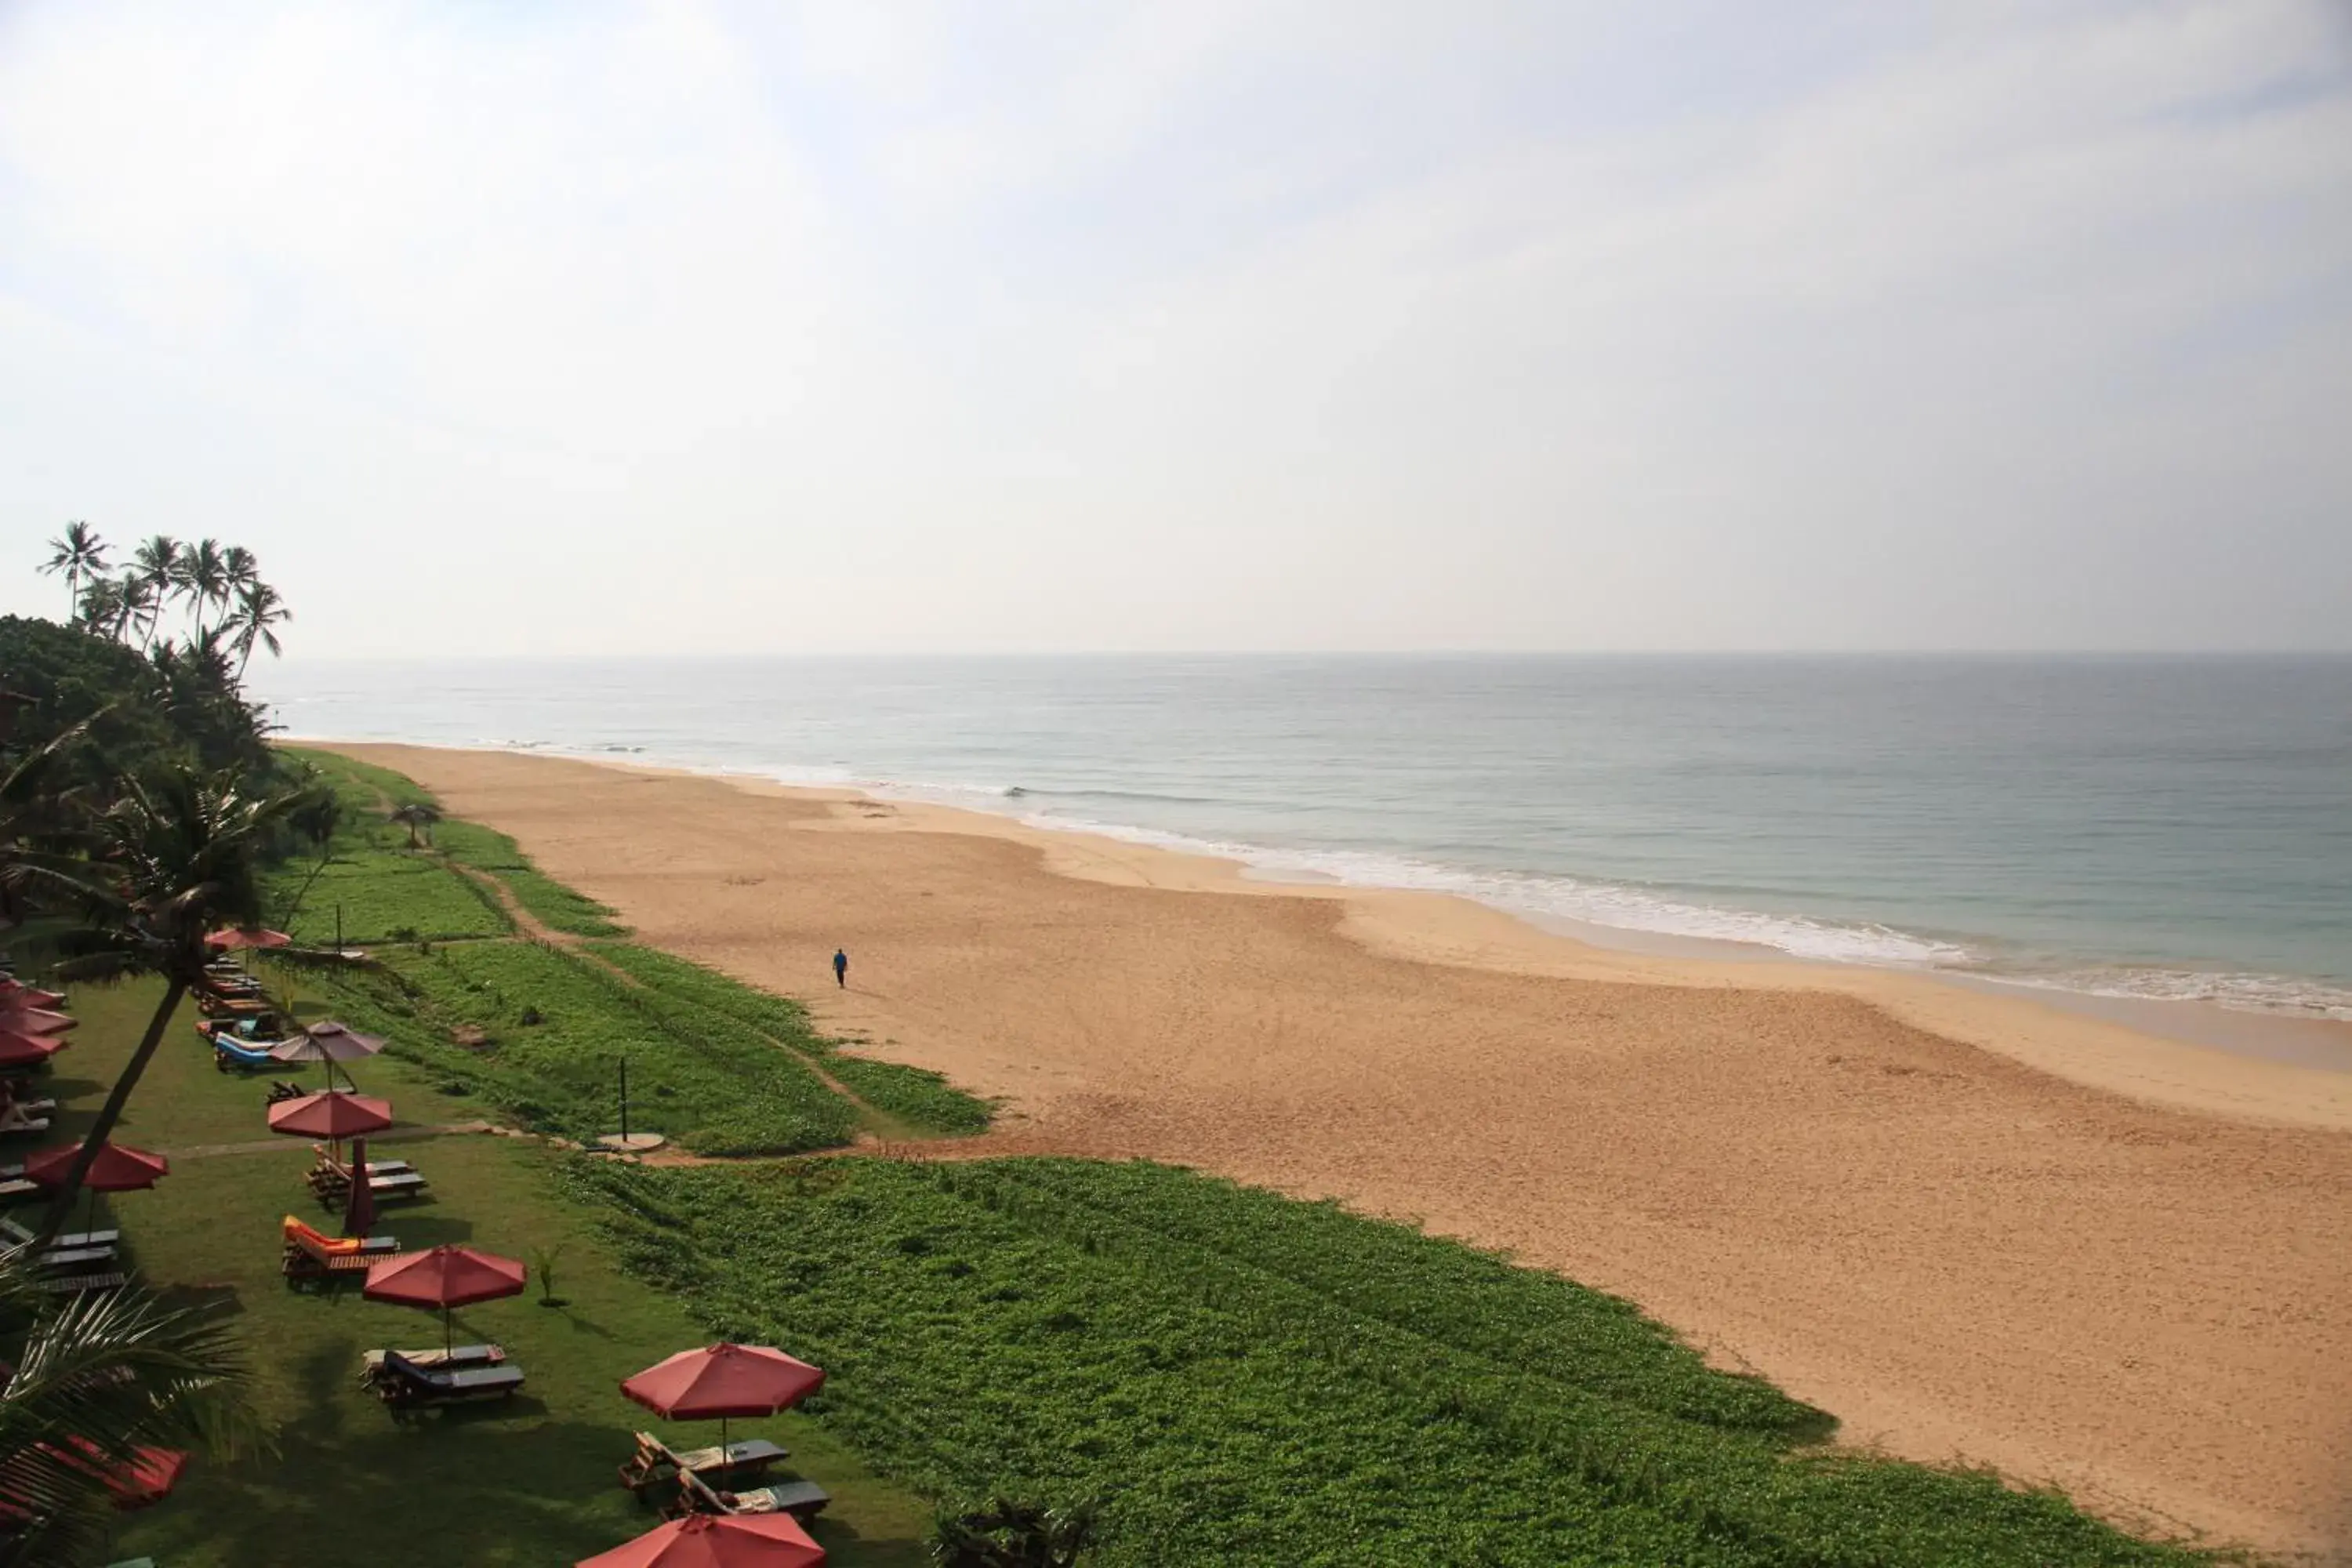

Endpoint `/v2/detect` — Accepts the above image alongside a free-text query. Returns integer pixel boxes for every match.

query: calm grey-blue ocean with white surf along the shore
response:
[254,656,2352,1020]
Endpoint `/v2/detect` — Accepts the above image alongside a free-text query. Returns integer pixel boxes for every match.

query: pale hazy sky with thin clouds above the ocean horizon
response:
[0,0,2352,659]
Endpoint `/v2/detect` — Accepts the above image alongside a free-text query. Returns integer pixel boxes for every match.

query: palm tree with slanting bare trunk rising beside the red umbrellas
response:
[40,767,301,1239]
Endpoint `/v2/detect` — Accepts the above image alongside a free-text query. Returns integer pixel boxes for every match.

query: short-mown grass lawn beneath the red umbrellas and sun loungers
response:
[27,985,931,1568]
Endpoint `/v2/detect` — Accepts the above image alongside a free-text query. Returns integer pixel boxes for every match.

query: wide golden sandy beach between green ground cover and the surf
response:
[341,746,2352,1561]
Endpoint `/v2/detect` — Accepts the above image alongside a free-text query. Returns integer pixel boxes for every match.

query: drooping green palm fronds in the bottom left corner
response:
[0,1246,270,1568]
